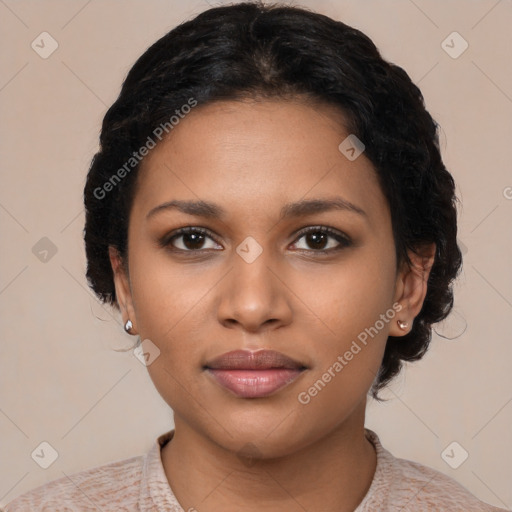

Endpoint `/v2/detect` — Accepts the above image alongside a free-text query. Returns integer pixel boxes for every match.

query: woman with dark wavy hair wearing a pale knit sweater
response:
[6,3,508,512]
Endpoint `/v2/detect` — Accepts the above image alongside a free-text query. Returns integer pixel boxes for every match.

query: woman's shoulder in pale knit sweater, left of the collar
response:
[3,456,144,512]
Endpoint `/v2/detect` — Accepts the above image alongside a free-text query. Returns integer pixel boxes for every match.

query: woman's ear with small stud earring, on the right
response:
[389,242,436,336]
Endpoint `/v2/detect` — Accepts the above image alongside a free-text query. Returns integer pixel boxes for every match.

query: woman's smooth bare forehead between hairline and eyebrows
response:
[133,100,387,226]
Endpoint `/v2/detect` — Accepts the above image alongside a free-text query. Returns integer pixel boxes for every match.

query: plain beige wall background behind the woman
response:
[0,0,512,508]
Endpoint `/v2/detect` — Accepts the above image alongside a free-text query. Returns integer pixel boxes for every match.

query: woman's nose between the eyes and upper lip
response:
[217,247,293,333]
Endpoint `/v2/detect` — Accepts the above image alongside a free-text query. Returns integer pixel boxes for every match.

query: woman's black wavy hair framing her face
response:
[84,2,462,400]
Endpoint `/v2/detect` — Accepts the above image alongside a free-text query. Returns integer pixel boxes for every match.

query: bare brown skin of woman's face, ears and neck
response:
[110,99,435,512]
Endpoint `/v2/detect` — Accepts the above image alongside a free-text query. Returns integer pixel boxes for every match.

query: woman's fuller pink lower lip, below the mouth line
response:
[208,368,303,398]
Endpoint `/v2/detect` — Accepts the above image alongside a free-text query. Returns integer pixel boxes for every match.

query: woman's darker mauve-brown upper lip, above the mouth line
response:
[205,350,305,370]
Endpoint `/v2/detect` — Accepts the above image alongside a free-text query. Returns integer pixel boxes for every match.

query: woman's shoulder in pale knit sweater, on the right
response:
[362,429,506,512]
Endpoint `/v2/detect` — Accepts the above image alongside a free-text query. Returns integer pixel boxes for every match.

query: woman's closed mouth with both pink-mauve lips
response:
[203,350,307,398]
